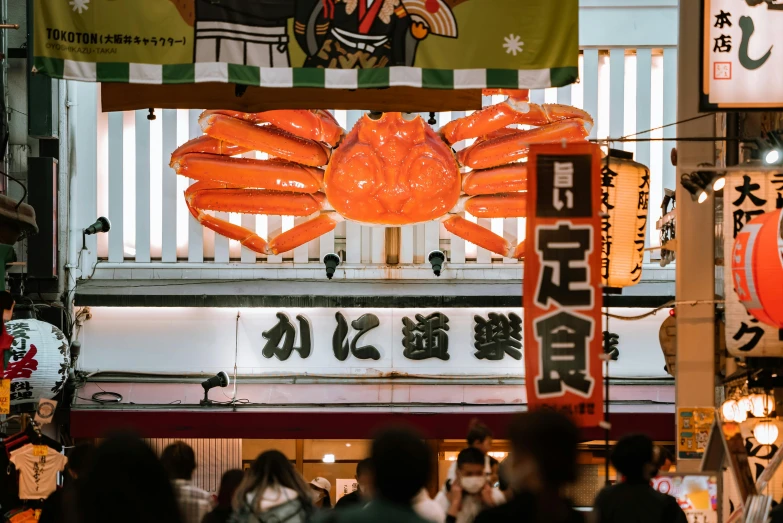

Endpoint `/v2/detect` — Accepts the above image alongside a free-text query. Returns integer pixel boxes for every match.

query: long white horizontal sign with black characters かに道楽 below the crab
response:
[79,304,666,378]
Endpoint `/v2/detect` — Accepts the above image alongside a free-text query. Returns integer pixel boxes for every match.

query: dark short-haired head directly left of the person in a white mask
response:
[371,427,431,505]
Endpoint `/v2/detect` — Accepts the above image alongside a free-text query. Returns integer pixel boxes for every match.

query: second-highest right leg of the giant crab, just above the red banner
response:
[457,119,589,169]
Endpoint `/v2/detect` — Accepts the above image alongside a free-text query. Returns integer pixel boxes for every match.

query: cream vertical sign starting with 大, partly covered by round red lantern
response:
[723,170,783,357]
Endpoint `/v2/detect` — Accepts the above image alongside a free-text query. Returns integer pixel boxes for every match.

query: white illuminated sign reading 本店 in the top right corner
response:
[702,0,783,109]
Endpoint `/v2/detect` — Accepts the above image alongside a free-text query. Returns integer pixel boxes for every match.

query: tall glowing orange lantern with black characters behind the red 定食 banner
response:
[601,149,650,287]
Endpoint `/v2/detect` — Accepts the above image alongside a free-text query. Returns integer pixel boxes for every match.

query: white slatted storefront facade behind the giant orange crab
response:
[50,0,677,508]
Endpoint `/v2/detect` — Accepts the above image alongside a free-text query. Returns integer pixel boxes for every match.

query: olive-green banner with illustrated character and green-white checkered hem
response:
[32,0,579,89]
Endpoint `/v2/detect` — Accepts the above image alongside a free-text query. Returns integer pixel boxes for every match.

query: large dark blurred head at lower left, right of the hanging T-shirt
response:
[78,434,182,523]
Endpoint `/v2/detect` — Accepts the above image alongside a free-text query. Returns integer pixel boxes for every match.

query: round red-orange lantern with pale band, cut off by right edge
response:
[731,209,783,329]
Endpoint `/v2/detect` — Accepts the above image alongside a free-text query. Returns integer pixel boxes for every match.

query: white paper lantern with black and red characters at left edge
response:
[4,319,70,407]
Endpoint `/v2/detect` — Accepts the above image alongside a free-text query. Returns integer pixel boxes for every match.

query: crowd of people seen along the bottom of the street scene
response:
[33,410,686,523]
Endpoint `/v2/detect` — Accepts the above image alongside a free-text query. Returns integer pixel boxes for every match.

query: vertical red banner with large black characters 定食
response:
[523,143,603,427]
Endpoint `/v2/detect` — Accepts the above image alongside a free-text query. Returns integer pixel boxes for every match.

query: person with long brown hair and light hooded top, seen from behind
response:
[230,450,315,523]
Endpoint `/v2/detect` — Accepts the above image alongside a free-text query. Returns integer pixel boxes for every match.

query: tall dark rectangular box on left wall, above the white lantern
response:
[27,157,57,279]
